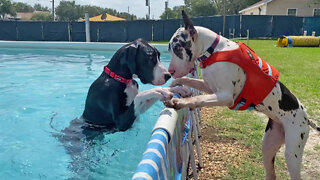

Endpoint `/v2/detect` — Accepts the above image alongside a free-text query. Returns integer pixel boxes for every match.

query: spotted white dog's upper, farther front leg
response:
[170,77,213,94]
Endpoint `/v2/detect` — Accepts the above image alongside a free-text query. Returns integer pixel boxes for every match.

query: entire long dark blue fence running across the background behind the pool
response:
[0,15,320,42]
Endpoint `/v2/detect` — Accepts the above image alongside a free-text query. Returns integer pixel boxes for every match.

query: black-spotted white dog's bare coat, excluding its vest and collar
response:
[166,12,320,180]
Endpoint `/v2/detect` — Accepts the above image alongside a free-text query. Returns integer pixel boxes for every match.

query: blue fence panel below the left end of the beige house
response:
[241,15,272,38]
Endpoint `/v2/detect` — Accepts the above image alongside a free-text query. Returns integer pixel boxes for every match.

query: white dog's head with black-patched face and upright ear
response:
[168,11,198,78]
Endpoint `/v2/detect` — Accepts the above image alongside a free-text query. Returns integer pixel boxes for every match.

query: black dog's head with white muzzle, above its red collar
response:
[115,39,171,85]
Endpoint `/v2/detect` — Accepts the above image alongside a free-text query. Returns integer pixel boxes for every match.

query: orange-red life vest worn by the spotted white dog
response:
[200,42,280,110]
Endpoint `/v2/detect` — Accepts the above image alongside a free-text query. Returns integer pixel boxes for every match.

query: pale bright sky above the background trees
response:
[13,0,184,19]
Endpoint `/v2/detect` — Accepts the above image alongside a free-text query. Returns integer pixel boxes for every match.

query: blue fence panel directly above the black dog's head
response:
[126,20,153,41]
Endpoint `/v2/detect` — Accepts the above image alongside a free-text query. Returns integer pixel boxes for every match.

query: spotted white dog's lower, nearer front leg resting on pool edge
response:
[165,92,234,109]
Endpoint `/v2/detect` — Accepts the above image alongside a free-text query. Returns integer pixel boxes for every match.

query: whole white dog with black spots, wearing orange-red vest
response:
[165,12,320,180]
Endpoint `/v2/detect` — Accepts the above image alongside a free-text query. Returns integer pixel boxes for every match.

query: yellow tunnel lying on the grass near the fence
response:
[277,36,320,47]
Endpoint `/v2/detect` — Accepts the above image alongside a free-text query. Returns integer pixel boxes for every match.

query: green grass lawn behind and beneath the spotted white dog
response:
[208,40,320,179]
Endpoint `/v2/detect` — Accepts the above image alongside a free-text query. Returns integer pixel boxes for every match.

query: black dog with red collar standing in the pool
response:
[55,39,190,175]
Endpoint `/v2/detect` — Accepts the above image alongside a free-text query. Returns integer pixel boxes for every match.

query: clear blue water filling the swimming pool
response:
[0,49,169,180]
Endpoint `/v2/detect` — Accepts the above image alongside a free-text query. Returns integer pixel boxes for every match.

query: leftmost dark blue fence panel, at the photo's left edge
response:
[0,21,17,41]
